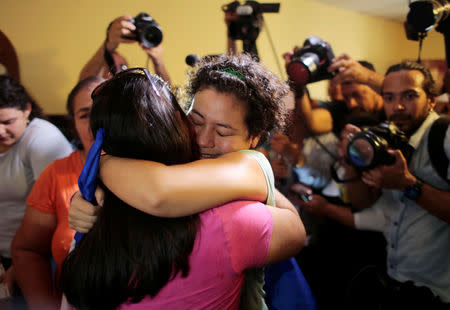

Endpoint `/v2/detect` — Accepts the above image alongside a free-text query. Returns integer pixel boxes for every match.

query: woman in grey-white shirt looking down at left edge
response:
[0,75,72,308]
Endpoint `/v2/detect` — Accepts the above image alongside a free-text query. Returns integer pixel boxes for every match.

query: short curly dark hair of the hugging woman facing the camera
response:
[188,54,289,144]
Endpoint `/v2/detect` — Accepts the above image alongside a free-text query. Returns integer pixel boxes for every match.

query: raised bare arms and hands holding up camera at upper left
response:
[79,15,170,84]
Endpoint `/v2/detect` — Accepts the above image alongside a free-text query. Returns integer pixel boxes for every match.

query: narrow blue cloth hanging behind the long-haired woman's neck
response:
[74,128,105,243]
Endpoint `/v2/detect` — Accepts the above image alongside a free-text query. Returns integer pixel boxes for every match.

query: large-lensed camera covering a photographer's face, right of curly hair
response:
[286,36,334,86]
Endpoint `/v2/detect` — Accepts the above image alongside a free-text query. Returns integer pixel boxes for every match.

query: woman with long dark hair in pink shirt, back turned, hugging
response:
[61,69,303,309]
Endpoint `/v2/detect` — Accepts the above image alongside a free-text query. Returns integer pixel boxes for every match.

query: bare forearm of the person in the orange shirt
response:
[13,249,59,310]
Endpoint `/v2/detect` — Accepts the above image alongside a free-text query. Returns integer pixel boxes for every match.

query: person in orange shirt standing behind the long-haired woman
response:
[12,77,104,310]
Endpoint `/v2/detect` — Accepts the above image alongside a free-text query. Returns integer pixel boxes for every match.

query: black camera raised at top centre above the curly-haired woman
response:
[222,1,280,41]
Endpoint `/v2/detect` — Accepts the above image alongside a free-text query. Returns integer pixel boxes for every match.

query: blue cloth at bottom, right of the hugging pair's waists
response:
[264,258,317,310]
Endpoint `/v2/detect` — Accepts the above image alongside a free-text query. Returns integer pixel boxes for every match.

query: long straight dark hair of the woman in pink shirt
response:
[60,73,199,309]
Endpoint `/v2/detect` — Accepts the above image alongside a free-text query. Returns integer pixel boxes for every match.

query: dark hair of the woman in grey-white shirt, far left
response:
[0,75,45,120]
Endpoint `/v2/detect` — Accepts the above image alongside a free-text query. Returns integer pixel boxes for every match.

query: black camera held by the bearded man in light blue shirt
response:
[347,122,411,171]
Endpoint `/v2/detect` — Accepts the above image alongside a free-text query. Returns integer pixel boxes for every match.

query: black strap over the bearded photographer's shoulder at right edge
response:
[428,116,450,184]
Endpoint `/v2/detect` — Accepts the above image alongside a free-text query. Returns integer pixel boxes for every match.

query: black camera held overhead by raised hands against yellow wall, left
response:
[131,13,162,48]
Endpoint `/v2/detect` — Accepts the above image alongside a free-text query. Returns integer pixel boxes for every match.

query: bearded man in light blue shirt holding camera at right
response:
[330,62,450,309]
